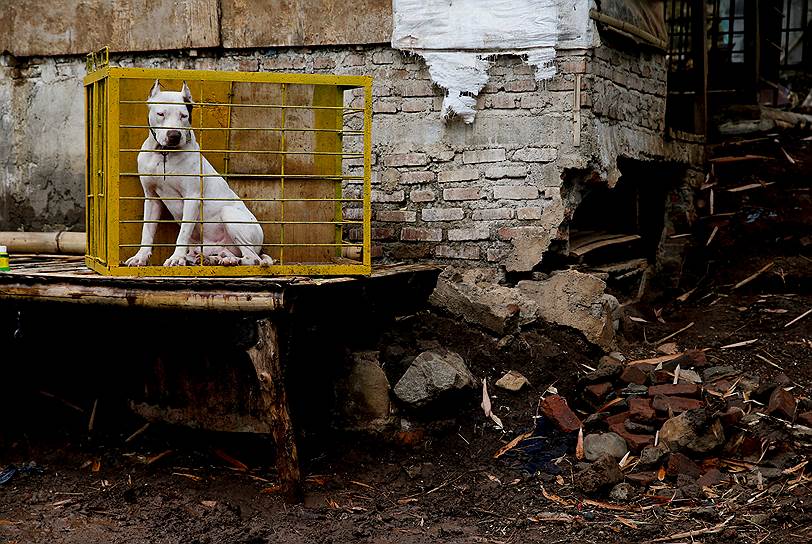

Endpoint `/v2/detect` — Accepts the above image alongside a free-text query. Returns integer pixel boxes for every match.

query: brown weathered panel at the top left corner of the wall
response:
[0,0,219,57]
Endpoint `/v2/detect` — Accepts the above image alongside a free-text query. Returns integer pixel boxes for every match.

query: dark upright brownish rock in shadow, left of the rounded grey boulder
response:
[336,351,390,427]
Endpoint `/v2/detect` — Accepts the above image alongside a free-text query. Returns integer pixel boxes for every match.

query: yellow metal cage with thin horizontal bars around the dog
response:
[84,54,372,276]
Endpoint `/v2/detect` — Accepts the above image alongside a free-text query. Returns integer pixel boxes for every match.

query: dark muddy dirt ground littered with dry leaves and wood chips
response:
[0,134,812,544]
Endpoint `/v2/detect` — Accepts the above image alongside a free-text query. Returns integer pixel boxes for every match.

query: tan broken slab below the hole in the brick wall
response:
[517,270,620,351]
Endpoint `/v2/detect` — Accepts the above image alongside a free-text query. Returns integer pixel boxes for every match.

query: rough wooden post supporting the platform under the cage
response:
[248,319,303,503]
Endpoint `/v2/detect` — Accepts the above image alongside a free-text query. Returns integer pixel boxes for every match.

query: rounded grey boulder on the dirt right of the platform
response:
[395,349,477,406]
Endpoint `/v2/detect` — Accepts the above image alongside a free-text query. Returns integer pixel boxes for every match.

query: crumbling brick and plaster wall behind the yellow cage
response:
[0,38,696,270]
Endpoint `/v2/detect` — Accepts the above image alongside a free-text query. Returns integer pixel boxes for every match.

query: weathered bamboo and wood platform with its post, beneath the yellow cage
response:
[0,256,440,502]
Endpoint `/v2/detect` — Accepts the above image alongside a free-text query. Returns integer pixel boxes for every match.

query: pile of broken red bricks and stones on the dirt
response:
[540,350,812,500]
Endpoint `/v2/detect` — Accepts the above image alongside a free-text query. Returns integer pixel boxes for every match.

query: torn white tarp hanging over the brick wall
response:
[392,0,592,123]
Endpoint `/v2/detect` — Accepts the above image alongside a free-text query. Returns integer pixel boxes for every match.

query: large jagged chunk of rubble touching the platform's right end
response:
[429,267,538,336]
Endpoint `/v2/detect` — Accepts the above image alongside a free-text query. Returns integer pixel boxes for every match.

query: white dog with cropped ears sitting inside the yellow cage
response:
[124,80,274,266]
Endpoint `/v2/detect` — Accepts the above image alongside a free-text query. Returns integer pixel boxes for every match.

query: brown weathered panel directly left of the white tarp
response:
[221,0,392,48]
